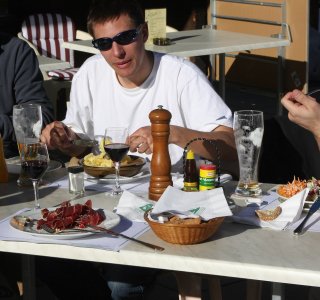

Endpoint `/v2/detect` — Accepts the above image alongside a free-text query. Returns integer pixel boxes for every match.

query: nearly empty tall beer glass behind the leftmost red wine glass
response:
[12,104,42,186]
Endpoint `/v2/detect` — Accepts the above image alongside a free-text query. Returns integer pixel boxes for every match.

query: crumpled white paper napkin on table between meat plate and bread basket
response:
[116,190,154,222]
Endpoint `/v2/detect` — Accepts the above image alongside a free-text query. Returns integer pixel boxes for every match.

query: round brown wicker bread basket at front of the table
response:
[144,212,224,245]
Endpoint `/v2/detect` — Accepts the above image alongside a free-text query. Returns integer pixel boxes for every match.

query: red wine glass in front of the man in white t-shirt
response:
[104,127,130,196]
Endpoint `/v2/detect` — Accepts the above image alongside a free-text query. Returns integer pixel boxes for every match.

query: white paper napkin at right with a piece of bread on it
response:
[232,188,309,230]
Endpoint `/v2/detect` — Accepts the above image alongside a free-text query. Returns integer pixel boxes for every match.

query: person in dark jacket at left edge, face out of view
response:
[0,32,54,158]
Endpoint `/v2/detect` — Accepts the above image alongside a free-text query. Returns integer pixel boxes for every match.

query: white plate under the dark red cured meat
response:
[10,207,120,240]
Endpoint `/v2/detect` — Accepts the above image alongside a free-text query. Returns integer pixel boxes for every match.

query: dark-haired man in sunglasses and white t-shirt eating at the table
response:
[41,0,237,299]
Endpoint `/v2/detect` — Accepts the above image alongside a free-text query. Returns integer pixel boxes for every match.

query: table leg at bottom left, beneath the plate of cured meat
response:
[22,255,36,300]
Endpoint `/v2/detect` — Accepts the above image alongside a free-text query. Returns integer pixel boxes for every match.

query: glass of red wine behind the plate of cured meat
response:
[20,142,50,209]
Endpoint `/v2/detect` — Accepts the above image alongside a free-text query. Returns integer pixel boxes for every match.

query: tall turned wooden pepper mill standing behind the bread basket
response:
[149,105,172,201]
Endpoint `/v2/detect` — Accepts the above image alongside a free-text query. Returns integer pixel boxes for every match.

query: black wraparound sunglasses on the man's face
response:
[92,24,142,51]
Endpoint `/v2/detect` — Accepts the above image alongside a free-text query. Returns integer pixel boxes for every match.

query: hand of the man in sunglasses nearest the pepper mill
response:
[130,126,153,154]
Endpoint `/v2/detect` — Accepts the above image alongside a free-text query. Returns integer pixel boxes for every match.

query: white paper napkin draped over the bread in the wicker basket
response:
[151,186,232,221]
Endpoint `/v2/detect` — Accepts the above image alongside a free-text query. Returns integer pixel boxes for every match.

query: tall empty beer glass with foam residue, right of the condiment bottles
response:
[233,110,264,196]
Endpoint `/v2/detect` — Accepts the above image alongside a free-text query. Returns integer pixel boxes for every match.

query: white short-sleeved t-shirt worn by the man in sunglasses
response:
[63,53,232,165]
